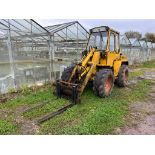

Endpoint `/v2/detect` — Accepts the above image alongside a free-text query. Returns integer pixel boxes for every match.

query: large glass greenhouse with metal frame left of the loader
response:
[0,19,88,93]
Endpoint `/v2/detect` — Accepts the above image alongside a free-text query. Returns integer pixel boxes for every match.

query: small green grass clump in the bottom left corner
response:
[0,120,17,135]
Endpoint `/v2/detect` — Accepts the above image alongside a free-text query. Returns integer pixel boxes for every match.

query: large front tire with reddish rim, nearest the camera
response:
[93,69,114,97]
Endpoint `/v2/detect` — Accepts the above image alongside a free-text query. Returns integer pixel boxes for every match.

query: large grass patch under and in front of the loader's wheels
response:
[40,80,152,134]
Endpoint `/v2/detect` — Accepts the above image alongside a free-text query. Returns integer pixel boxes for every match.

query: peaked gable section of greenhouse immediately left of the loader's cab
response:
[45,21,88,79]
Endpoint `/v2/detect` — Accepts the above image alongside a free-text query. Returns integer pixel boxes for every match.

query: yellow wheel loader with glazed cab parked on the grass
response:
[56,26,128,104]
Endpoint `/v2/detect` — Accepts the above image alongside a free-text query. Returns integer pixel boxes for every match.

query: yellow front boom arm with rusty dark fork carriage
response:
[56,48,100,104]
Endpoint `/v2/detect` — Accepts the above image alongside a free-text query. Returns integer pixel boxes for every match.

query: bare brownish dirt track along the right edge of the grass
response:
[115,69,155,135]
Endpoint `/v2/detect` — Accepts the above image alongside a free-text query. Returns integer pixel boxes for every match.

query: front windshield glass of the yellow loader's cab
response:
[87,31,108,50]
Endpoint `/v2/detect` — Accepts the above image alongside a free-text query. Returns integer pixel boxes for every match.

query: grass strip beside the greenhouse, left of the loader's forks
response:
[0,85,55,134]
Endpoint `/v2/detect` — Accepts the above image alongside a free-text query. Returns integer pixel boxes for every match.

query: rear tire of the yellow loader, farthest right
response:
[116,65,129,87]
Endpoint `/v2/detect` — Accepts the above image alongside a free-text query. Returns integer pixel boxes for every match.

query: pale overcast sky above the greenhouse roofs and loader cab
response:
[36,19,155,34]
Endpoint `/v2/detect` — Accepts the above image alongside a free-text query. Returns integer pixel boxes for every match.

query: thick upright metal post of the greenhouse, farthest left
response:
[7,19,17,90]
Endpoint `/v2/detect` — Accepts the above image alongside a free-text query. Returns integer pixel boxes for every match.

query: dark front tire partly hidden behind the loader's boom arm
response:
[61,65,75,81]
